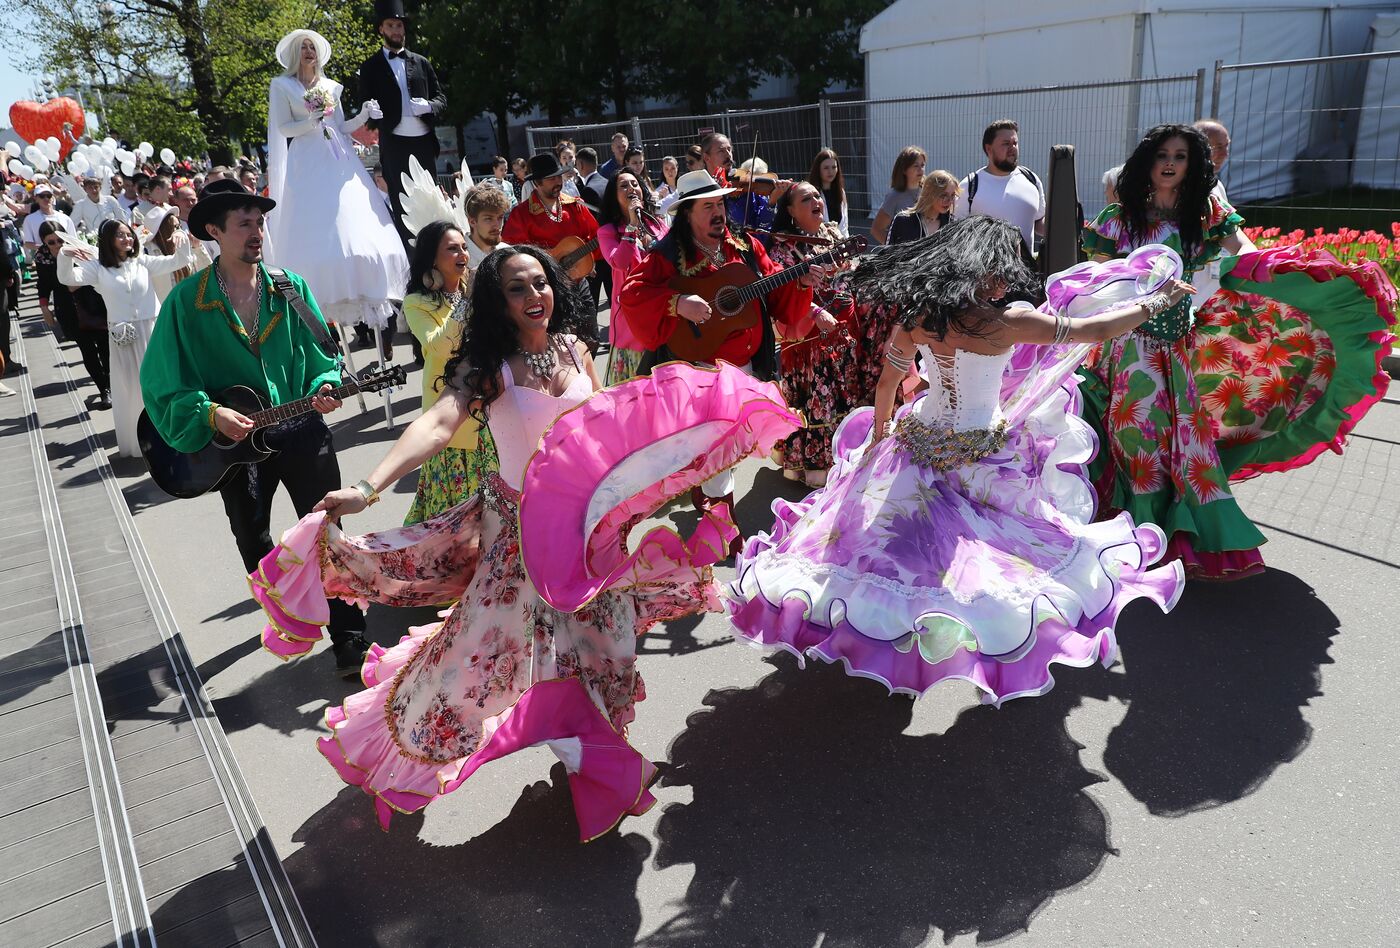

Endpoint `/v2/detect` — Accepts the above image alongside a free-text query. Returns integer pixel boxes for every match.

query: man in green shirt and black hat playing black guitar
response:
[141,179,368,678]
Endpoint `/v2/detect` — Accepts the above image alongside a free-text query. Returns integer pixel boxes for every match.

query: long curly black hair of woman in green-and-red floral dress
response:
[1119,125,1215,256]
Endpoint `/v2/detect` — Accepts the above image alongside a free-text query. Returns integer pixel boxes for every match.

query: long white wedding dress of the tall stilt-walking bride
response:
[265,76,409,328]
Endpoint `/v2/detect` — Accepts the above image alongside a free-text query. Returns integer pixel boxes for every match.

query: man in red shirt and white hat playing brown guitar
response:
[619,171,820,534]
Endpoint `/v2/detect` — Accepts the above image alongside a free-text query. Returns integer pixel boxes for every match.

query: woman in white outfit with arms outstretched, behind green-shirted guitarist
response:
[59,220,195,458]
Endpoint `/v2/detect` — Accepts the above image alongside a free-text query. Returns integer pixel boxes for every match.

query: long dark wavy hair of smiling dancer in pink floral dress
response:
[438,244,598,424]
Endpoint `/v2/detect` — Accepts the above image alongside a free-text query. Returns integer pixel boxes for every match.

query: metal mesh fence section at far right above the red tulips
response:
[1211,52,1400,237]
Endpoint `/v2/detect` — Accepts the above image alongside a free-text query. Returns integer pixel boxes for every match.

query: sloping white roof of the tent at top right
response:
[861,0,1377,53]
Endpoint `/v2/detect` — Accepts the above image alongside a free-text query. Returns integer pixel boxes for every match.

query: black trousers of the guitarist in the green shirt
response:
[218,416,364,643]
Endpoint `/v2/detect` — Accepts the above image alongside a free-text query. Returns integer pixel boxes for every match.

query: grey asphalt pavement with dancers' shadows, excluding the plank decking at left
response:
[71,312,1400,948]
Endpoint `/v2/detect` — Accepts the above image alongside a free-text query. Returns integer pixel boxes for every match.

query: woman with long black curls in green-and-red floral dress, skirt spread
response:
[1084,125,1394,580]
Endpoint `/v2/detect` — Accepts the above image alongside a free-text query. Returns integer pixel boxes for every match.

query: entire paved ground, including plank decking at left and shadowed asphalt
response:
[0,282,1400,948]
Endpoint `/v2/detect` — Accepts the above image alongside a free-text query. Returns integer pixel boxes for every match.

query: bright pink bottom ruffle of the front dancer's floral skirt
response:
[316,672,657,843]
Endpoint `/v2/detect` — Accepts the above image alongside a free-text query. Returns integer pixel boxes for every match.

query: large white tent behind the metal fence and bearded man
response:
[861,0,1400,213]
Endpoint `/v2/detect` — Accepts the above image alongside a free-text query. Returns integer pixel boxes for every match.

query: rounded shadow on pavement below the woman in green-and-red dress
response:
[1103,570,1338,816]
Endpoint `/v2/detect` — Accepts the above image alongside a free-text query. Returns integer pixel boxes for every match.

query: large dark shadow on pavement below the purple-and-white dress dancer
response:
[645,655,1113,948]
